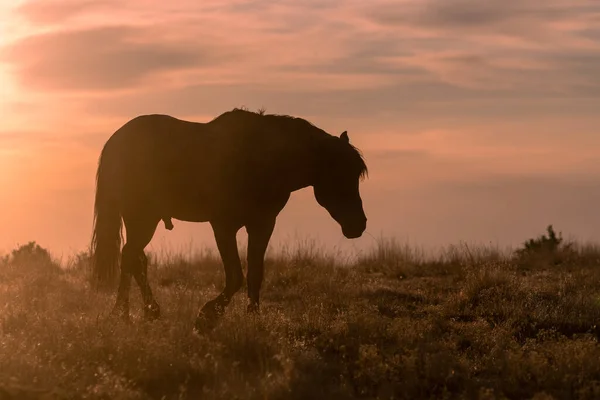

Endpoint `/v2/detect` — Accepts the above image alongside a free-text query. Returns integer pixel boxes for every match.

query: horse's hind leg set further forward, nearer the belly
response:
[121,217,160,320]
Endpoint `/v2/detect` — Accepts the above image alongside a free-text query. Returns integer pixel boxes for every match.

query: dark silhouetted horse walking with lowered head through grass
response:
[91,108,368,329]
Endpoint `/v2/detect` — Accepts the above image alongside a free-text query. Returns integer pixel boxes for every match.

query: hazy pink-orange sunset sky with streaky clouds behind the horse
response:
[0,0,600,255]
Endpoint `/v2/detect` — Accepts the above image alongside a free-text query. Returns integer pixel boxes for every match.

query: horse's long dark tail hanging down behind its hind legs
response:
[91,146,123,288]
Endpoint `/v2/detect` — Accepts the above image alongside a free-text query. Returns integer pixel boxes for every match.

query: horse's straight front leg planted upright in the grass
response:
[246,217,275,312]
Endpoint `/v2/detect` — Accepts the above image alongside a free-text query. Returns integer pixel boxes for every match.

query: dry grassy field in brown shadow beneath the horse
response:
[0,234,600,399]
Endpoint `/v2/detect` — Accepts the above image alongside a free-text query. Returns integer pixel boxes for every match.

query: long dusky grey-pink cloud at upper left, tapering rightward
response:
[4,26,241,91]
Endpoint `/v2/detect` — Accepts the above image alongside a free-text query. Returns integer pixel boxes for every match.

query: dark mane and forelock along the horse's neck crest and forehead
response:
[211,107,369,180]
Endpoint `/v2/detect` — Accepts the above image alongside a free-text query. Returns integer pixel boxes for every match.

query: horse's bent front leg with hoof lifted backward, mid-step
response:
[196,223,244,329]
